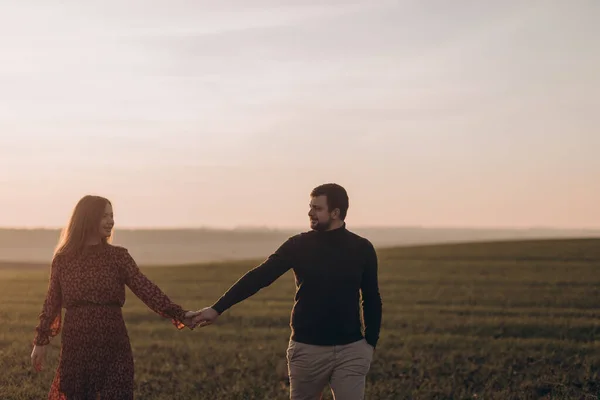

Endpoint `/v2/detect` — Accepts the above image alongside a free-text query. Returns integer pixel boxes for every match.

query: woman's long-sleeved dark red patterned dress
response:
[33,244,186,400]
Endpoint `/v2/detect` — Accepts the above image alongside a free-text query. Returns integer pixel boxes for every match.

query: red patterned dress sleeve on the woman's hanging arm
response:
[33,257,62,346]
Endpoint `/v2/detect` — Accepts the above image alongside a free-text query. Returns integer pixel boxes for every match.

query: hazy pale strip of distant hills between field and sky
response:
[0,225,600,265]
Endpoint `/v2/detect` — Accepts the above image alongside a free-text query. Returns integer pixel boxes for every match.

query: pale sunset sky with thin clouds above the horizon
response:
[0,0,600,228]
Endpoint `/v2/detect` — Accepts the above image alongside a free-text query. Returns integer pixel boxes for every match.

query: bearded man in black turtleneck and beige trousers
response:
[195,183,382,400]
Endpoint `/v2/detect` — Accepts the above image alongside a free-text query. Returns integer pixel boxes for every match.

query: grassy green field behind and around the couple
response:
[0,239,600,400]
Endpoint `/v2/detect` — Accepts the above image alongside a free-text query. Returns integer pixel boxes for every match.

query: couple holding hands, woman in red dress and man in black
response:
[31,183,382,400]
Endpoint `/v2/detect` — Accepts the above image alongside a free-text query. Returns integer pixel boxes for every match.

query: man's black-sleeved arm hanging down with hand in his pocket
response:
[360,242,382,348]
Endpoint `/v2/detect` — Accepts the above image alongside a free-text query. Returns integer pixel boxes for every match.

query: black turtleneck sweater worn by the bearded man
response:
[212,225,382,347]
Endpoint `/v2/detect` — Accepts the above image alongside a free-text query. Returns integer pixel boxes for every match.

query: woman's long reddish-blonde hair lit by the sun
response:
[54,195,112,256]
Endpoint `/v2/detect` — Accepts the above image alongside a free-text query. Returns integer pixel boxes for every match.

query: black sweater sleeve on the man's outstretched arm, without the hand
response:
[211,238,297,314]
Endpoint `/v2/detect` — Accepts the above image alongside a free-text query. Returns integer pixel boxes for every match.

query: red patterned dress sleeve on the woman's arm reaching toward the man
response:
[120,249,186,329]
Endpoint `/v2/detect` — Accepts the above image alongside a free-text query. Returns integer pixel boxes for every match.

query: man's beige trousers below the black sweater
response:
[287,339,374,400]
